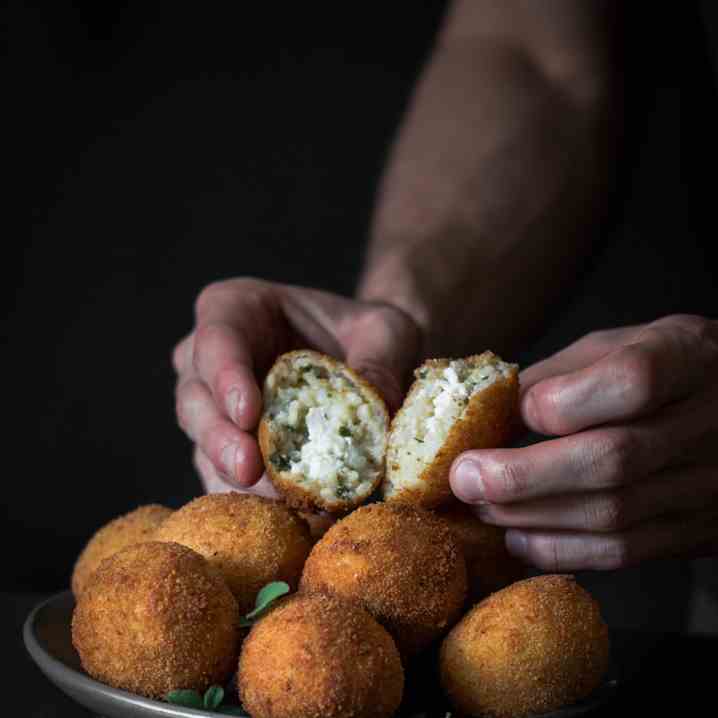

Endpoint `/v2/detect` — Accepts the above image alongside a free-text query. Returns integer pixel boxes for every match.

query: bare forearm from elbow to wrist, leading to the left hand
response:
[359,0,610,355]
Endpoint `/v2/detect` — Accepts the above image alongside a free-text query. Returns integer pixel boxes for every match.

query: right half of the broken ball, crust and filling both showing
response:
[381,351,519,508]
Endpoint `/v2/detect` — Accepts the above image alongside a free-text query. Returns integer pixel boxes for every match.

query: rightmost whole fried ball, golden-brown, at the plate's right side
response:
[439,576,609,718]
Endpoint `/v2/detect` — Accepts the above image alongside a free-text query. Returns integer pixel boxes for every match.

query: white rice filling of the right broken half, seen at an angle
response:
[386,359,515,496]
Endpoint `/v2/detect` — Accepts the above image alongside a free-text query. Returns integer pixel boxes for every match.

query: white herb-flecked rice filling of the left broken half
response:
[267,357,385,501]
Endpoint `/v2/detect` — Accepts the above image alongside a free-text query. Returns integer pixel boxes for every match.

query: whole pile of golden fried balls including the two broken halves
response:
[72,351,609,718]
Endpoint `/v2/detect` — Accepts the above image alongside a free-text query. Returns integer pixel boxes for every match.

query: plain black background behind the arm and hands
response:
[8,2,718,591]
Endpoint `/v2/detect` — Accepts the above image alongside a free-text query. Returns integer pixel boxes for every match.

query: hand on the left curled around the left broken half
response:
[172,278,420,496]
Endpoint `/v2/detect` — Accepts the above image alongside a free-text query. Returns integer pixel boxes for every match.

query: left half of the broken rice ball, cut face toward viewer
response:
[259,350,389,514]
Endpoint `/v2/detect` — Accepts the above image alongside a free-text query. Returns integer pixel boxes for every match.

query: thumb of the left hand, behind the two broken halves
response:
[346,305,420,412]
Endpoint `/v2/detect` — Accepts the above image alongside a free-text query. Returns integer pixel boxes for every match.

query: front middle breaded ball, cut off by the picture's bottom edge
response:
[237,594,404,718]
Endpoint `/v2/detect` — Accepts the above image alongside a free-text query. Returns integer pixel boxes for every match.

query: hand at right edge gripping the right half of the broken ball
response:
[451,315,718,571]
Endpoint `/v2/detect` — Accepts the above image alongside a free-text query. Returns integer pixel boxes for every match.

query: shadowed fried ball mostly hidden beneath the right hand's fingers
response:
[436,501,526,602]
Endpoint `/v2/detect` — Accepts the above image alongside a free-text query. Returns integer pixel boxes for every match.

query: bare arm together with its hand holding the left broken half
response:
[173,0,612,495]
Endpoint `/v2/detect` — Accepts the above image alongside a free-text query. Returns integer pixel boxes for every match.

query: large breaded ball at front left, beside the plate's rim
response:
[72,542,239,698]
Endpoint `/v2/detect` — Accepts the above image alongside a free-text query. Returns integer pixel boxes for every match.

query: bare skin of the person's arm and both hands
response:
[174,0,718,571]
